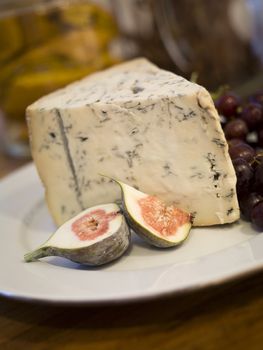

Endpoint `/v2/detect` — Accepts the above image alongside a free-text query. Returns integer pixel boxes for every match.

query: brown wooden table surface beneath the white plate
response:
[0,155,263,350]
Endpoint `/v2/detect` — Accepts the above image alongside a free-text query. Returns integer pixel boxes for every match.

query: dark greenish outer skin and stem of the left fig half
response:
[24,213,131,266]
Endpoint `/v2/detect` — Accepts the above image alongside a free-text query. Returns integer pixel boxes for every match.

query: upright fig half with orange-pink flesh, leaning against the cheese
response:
[114,180,192,248]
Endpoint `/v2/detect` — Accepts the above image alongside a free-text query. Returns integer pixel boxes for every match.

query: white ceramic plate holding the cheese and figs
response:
[0,164,263,303]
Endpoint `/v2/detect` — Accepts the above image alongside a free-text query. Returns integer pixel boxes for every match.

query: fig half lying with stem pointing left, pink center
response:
[24,203,130,265]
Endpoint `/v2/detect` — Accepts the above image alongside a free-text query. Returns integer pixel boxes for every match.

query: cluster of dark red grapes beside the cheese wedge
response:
[215,90,263,229]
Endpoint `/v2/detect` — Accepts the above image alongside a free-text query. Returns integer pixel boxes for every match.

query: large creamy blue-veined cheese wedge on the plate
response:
[27,59,239,226]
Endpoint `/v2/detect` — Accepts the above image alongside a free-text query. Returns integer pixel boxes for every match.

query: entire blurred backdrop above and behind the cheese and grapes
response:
[0,0,263,158]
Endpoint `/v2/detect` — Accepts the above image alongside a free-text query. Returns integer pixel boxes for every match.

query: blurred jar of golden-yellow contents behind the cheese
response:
[0,0,120,157]
